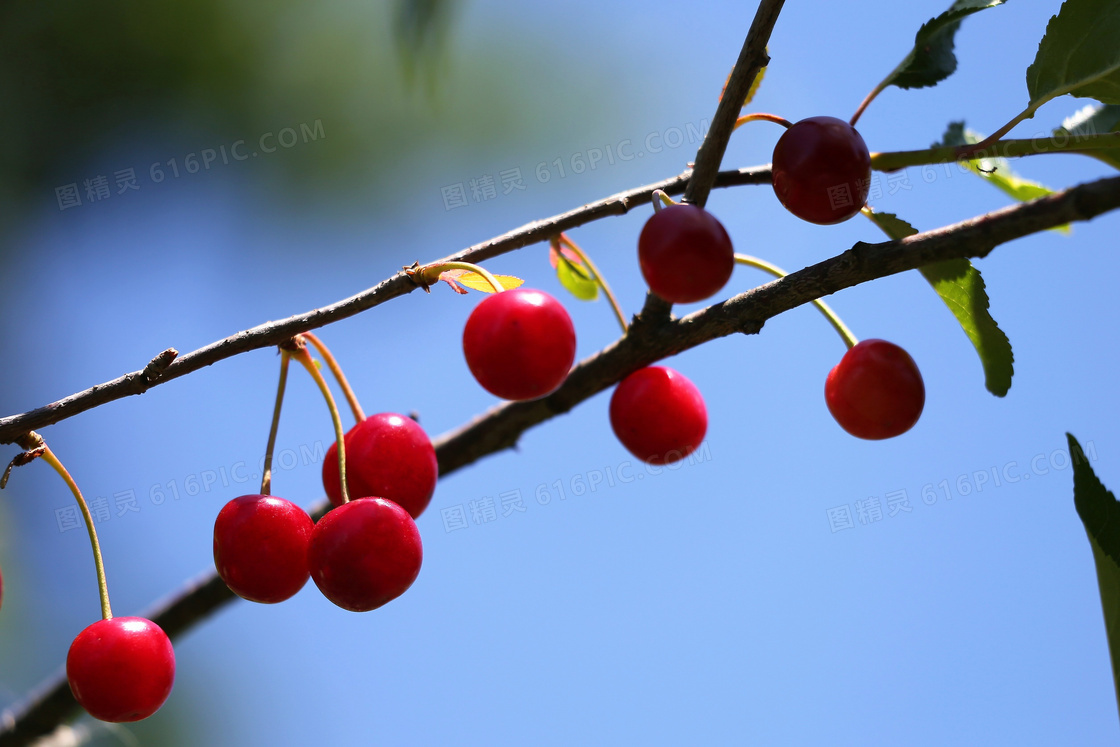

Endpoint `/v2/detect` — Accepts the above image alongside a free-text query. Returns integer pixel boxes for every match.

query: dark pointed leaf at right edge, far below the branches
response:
[1065,433,1120,708]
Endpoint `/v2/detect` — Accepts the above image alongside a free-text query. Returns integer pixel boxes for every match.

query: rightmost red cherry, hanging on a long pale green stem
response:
[824,339,925,440]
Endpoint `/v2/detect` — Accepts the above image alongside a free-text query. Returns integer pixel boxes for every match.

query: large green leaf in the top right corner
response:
[1027,0,1120,110]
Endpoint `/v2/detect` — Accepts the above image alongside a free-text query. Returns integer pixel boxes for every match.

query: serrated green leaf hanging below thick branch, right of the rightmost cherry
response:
[867,212,1015,396]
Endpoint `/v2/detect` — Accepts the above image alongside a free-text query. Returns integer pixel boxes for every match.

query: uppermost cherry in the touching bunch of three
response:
[323,412,439,519]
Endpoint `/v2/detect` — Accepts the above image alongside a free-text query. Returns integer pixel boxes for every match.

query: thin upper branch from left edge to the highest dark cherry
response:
[0,167,769,443]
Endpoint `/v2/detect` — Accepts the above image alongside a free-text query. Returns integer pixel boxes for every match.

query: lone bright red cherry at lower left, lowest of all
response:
[66,617,175,722]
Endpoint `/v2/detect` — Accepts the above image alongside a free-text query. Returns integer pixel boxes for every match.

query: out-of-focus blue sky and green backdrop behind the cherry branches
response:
[0,0,1120,746]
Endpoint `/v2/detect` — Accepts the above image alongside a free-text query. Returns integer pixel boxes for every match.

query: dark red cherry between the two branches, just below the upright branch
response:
[637,204,735,304]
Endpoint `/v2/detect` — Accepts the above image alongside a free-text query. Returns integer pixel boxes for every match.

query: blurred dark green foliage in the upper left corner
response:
[0,0,609,227]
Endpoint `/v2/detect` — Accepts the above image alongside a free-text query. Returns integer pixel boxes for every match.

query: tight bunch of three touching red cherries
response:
[214,413,439,611]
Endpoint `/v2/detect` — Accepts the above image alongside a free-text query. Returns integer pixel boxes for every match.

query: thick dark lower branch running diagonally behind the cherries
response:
[8,171,1120,747]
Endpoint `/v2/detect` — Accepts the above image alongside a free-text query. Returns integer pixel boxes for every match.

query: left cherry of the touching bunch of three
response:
[214,495,315,605]
